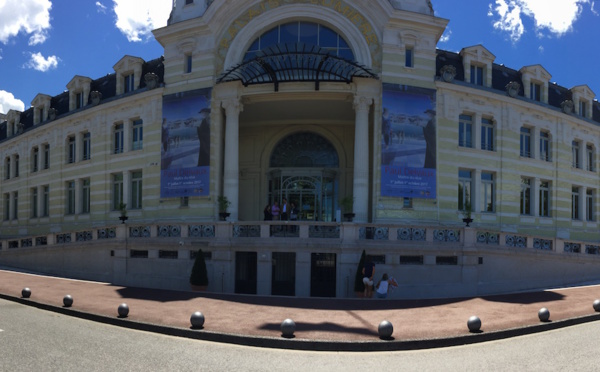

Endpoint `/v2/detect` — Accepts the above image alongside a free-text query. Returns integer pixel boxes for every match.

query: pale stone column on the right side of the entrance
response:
[353,96,373,222]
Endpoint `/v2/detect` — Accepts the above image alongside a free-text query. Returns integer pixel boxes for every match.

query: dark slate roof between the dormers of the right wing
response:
[436,49,600,123]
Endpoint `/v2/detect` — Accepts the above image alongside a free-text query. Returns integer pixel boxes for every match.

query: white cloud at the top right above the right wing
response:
[488,0,595,42]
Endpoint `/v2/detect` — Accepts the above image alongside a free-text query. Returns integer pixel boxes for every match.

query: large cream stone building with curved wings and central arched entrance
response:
[0,0,600,298]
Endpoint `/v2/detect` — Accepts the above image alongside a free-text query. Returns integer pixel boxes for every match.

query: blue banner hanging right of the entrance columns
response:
[381,84,437,198]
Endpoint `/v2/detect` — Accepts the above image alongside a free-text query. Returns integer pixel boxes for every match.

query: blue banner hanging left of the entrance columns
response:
[160,89,211,198]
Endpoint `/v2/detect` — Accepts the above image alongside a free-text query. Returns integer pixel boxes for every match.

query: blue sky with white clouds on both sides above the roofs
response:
[0,0,600,113]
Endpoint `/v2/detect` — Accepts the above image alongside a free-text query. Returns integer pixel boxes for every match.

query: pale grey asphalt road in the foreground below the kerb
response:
[0,300,600,372]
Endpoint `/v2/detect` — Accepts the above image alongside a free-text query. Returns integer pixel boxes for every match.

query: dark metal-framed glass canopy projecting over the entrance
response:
[217,43,378,92]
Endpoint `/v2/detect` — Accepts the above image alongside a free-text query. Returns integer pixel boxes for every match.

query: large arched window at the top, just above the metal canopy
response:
[244,21,354,61]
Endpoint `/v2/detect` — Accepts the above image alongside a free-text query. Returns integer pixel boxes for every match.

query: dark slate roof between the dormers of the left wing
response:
[0,57,165,141]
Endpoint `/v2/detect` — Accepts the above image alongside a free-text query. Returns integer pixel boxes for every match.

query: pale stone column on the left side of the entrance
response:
[221,98,244,221]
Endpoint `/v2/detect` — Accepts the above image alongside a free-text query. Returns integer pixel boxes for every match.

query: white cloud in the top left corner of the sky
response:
[0,0,52,45]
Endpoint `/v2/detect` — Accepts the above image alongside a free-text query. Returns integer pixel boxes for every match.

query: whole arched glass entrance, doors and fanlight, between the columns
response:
[267,131,340,221]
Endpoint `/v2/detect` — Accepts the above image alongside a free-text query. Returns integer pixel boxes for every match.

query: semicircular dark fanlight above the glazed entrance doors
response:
[270,132,339,168]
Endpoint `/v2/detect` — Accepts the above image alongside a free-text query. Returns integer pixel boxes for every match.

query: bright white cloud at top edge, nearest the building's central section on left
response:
[113,0,173,41]
